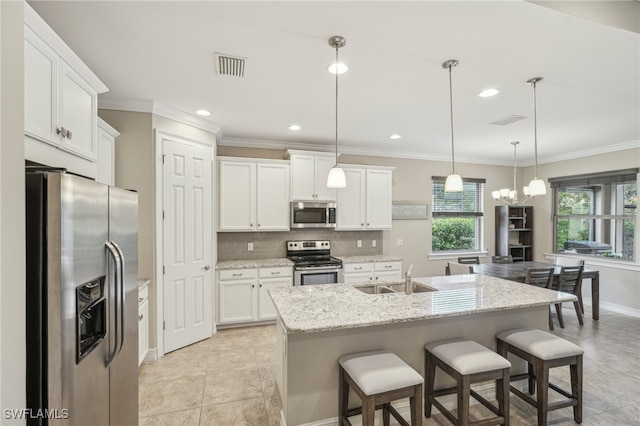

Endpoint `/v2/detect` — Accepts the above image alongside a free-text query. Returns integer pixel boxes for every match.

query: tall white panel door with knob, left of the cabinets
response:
[162,139,214,353]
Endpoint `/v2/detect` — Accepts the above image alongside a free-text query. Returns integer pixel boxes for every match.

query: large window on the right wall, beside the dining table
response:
[549,169,638,260]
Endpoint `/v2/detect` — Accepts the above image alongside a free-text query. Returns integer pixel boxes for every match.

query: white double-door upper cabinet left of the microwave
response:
[218,159,290,231]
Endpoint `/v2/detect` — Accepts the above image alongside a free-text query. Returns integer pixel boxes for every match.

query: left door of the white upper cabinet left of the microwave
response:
[219,161,256,231]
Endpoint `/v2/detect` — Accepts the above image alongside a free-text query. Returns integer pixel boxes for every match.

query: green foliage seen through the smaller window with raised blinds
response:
[431,218,475,252]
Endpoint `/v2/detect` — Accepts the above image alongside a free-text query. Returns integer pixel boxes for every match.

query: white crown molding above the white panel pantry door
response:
[98,98,222,137]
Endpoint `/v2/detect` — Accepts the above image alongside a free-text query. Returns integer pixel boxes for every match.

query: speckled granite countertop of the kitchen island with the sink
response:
[269,274,577,333]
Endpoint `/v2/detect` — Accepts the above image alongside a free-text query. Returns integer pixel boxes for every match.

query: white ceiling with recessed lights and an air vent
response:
[29,0,640,164]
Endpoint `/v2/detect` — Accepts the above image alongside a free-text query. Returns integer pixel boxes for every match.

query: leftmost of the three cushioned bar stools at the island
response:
[338,350,423,426]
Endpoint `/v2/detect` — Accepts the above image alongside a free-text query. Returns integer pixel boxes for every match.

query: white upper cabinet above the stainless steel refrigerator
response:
[24,3,108,178]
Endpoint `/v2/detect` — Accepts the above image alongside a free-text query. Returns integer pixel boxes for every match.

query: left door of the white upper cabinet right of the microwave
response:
[336,168,366,230]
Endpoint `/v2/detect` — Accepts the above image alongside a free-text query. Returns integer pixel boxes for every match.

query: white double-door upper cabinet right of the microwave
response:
[337,166,393,230]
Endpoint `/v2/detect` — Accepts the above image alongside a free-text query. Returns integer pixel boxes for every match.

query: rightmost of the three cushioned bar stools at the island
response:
[496,328,584,426]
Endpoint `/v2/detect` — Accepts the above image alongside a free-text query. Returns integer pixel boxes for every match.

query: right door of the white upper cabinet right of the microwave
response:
[366,169,392,229]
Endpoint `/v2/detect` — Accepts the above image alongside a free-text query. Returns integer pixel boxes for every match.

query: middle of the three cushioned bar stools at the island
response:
[424,340,511,425]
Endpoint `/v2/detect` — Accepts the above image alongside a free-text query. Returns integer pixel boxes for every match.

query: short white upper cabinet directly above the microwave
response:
[288,151,336,201]
